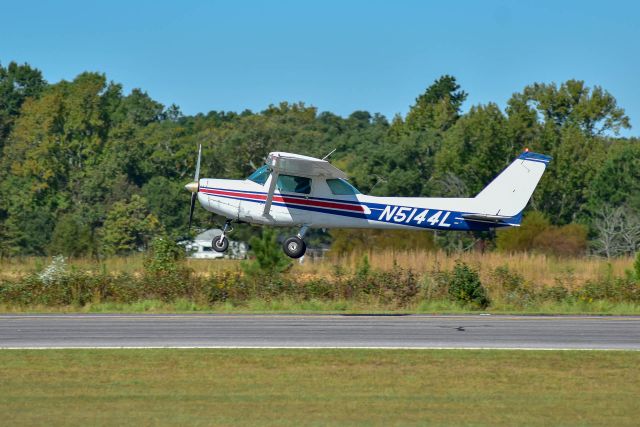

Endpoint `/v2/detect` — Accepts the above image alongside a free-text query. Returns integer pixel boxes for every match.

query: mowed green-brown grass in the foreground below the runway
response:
[0,349,640,426]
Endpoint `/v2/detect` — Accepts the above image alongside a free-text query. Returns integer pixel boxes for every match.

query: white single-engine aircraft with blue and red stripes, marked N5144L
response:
[185,146,551,258]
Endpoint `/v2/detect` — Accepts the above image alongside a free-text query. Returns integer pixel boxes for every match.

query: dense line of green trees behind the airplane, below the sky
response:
[0,62,640,257]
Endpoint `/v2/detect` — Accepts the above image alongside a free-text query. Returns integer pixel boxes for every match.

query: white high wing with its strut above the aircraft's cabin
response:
[262,151,347,216]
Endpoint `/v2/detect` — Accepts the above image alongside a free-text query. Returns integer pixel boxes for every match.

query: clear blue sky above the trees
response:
[0,0,640,136]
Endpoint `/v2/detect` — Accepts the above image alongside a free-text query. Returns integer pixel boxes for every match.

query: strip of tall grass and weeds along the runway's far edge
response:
[0,251,640,313]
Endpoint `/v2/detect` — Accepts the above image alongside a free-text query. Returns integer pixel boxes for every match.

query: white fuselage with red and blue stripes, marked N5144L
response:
[198,176,508,231]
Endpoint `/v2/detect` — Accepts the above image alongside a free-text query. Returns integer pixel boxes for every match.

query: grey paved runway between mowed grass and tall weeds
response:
[0,314,640,350]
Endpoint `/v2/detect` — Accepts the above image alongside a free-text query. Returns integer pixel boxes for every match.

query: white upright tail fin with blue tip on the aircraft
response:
[474,151,551,221]
